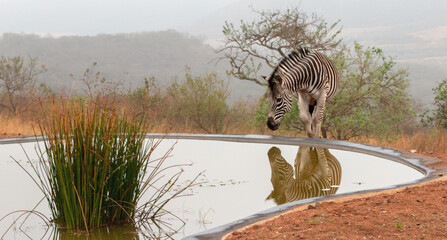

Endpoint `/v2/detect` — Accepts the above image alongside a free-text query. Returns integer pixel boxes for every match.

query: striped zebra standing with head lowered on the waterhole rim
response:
[263,48,338,138]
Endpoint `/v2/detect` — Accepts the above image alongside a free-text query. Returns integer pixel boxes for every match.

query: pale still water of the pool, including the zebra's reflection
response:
[0,136,425,239]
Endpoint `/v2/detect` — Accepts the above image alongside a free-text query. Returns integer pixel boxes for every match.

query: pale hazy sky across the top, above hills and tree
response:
[0,0,447,35]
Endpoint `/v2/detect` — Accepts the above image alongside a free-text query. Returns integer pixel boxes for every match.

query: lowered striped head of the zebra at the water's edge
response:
[263,75,292,131]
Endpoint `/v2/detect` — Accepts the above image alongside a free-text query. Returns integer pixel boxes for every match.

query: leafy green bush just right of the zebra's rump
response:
[322,43,415,140]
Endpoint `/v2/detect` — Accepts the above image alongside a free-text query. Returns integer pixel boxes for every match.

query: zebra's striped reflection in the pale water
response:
[267,147,341,204]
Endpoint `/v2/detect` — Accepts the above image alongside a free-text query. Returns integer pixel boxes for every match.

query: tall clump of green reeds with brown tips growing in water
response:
[12,101,194,235]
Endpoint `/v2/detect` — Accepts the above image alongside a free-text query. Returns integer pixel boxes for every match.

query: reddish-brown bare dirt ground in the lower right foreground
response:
[225,153,447,239]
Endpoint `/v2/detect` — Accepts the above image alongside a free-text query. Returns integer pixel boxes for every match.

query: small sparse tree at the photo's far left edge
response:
[0,56,47,115]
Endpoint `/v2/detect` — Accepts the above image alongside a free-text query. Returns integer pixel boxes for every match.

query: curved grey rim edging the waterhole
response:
[0,133,447,240]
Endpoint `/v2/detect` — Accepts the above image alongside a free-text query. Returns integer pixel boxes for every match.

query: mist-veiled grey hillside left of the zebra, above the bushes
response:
[0,31,263,99]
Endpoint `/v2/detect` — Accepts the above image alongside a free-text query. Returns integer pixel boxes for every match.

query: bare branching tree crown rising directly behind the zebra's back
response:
[219,8,341,85]
